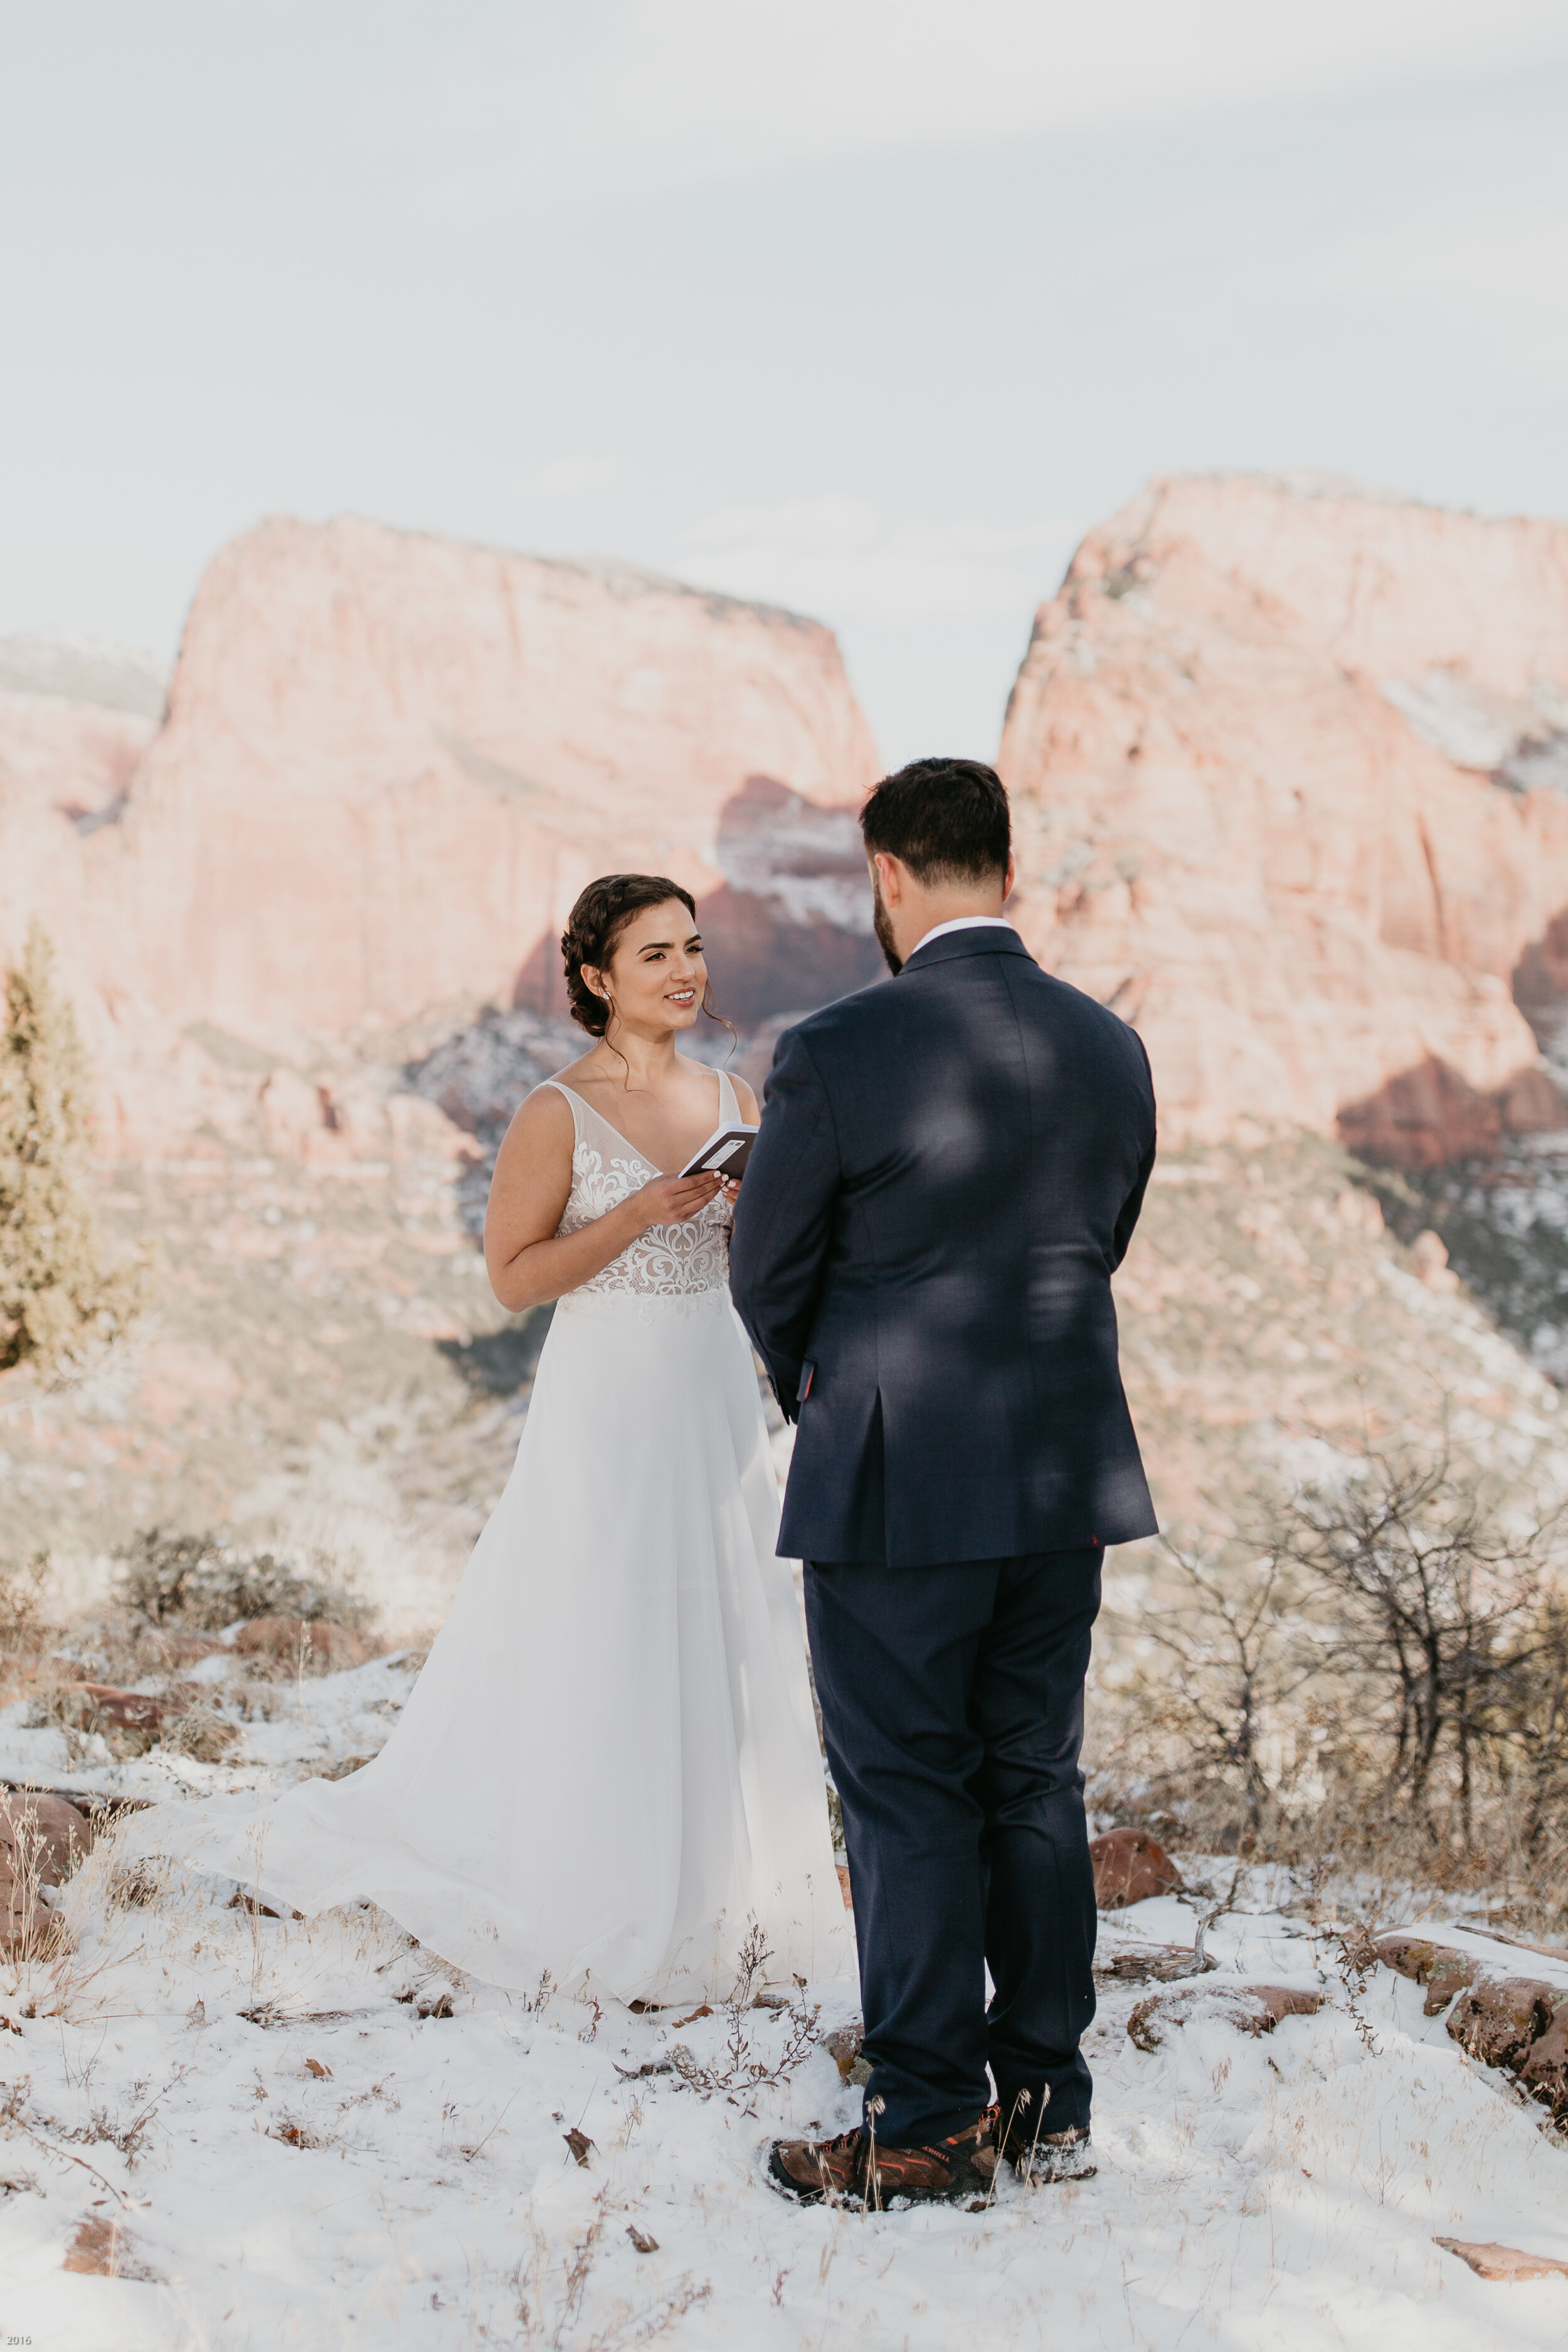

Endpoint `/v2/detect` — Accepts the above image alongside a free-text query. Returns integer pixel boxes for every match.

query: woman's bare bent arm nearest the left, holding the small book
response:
[484,1087,719,1315]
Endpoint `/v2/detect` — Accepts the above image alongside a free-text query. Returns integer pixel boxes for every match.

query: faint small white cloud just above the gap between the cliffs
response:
[677,496,1079,628]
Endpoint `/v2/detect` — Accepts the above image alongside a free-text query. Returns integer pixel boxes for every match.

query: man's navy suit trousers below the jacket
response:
[807,1545,1105,2148]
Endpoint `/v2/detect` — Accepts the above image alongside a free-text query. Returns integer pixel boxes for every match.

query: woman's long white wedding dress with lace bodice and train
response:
[157,1078,856,2001]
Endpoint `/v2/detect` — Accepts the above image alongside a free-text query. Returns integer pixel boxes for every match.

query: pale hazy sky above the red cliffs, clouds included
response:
[0,0,1568,762]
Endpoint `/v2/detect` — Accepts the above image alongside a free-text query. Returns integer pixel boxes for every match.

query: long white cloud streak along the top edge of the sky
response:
[416,0,1568,207]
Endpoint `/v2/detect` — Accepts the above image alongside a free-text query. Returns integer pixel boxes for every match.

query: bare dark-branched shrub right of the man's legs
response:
[1098,1446,1568,1919]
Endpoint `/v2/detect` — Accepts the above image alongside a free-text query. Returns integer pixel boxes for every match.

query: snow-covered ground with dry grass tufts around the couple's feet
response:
[0,1661,1568,2352]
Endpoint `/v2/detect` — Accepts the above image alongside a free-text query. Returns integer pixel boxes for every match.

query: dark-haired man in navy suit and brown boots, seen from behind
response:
[731,760,1154,2204]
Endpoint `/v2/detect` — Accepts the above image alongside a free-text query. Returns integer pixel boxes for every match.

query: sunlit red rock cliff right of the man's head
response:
[999,475,1568,1162]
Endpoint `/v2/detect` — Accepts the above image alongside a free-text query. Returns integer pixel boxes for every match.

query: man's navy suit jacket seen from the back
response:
[729,927,1157,1567]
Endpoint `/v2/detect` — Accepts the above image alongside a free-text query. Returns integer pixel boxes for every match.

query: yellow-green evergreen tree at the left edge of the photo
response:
[0,924,146,1374]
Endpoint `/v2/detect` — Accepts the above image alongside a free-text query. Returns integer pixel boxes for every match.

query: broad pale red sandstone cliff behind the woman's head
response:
[0,517,877,1141]
